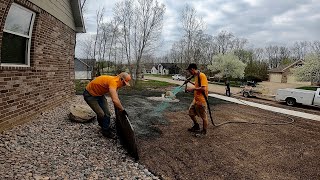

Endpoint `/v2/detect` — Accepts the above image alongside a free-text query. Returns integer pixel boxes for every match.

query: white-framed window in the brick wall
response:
[1,3,36,66]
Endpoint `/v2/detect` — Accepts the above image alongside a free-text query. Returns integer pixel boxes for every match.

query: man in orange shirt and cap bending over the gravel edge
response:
[83,72,131,138]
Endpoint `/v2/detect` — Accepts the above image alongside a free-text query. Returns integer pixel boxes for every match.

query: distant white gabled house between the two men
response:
[143,63,180,75]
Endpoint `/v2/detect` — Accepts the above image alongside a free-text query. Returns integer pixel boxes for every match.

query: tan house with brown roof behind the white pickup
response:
[269,60,304,84]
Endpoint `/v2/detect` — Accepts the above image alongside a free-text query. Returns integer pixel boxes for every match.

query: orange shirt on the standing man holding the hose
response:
[194,72,208,105]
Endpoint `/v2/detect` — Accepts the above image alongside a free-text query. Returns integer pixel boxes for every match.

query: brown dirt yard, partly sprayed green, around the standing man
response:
[120,87,320,179]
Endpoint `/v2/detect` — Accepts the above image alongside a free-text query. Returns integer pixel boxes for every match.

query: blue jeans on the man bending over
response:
[83,90,110,131]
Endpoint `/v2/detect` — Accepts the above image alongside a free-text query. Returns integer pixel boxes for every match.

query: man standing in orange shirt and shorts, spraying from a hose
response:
[187,63,208,135]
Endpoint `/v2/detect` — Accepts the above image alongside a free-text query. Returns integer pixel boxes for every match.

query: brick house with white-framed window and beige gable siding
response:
[0,0,85,132]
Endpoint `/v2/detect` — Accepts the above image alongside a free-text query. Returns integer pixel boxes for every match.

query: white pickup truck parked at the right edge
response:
[275,88,320,106]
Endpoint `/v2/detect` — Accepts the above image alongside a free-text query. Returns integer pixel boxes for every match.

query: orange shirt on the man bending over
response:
[86,75,122,96]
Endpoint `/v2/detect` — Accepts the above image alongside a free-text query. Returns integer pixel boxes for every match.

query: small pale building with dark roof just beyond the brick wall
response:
[74,58,96,79]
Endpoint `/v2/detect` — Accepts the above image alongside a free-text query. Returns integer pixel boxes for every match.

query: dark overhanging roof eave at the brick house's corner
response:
[70,0,86,33]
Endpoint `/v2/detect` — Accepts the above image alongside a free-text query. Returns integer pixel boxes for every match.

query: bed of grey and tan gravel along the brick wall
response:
[0,96,159,179]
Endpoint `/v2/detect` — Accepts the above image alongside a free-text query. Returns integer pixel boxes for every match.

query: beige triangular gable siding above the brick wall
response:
[29,0,76,30]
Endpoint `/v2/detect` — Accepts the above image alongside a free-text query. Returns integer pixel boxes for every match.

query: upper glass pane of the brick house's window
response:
[4,5,33,36]
